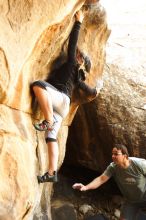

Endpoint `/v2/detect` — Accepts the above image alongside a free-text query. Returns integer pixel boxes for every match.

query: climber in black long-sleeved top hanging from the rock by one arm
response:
[31,10,97,183]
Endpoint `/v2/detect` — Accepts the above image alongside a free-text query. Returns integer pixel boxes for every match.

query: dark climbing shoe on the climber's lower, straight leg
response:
[37,171,58,183]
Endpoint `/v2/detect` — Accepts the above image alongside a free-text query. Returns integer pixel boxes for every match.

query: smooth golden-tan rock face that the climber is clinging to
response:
[0,0,109,220]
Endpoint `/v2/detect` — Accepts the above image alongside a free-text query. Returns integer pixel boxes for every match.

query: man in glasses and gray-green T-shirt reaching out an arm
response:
[73,144,146,220]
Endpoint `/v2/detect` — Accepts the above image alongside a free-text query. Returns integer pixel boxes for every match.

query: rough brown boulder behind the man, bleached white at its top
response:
[66,0,146,172]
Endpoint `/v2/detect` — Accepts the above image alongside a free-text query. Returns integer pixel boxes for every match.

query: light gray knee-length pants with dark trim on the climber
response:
[32,80,70,142]
